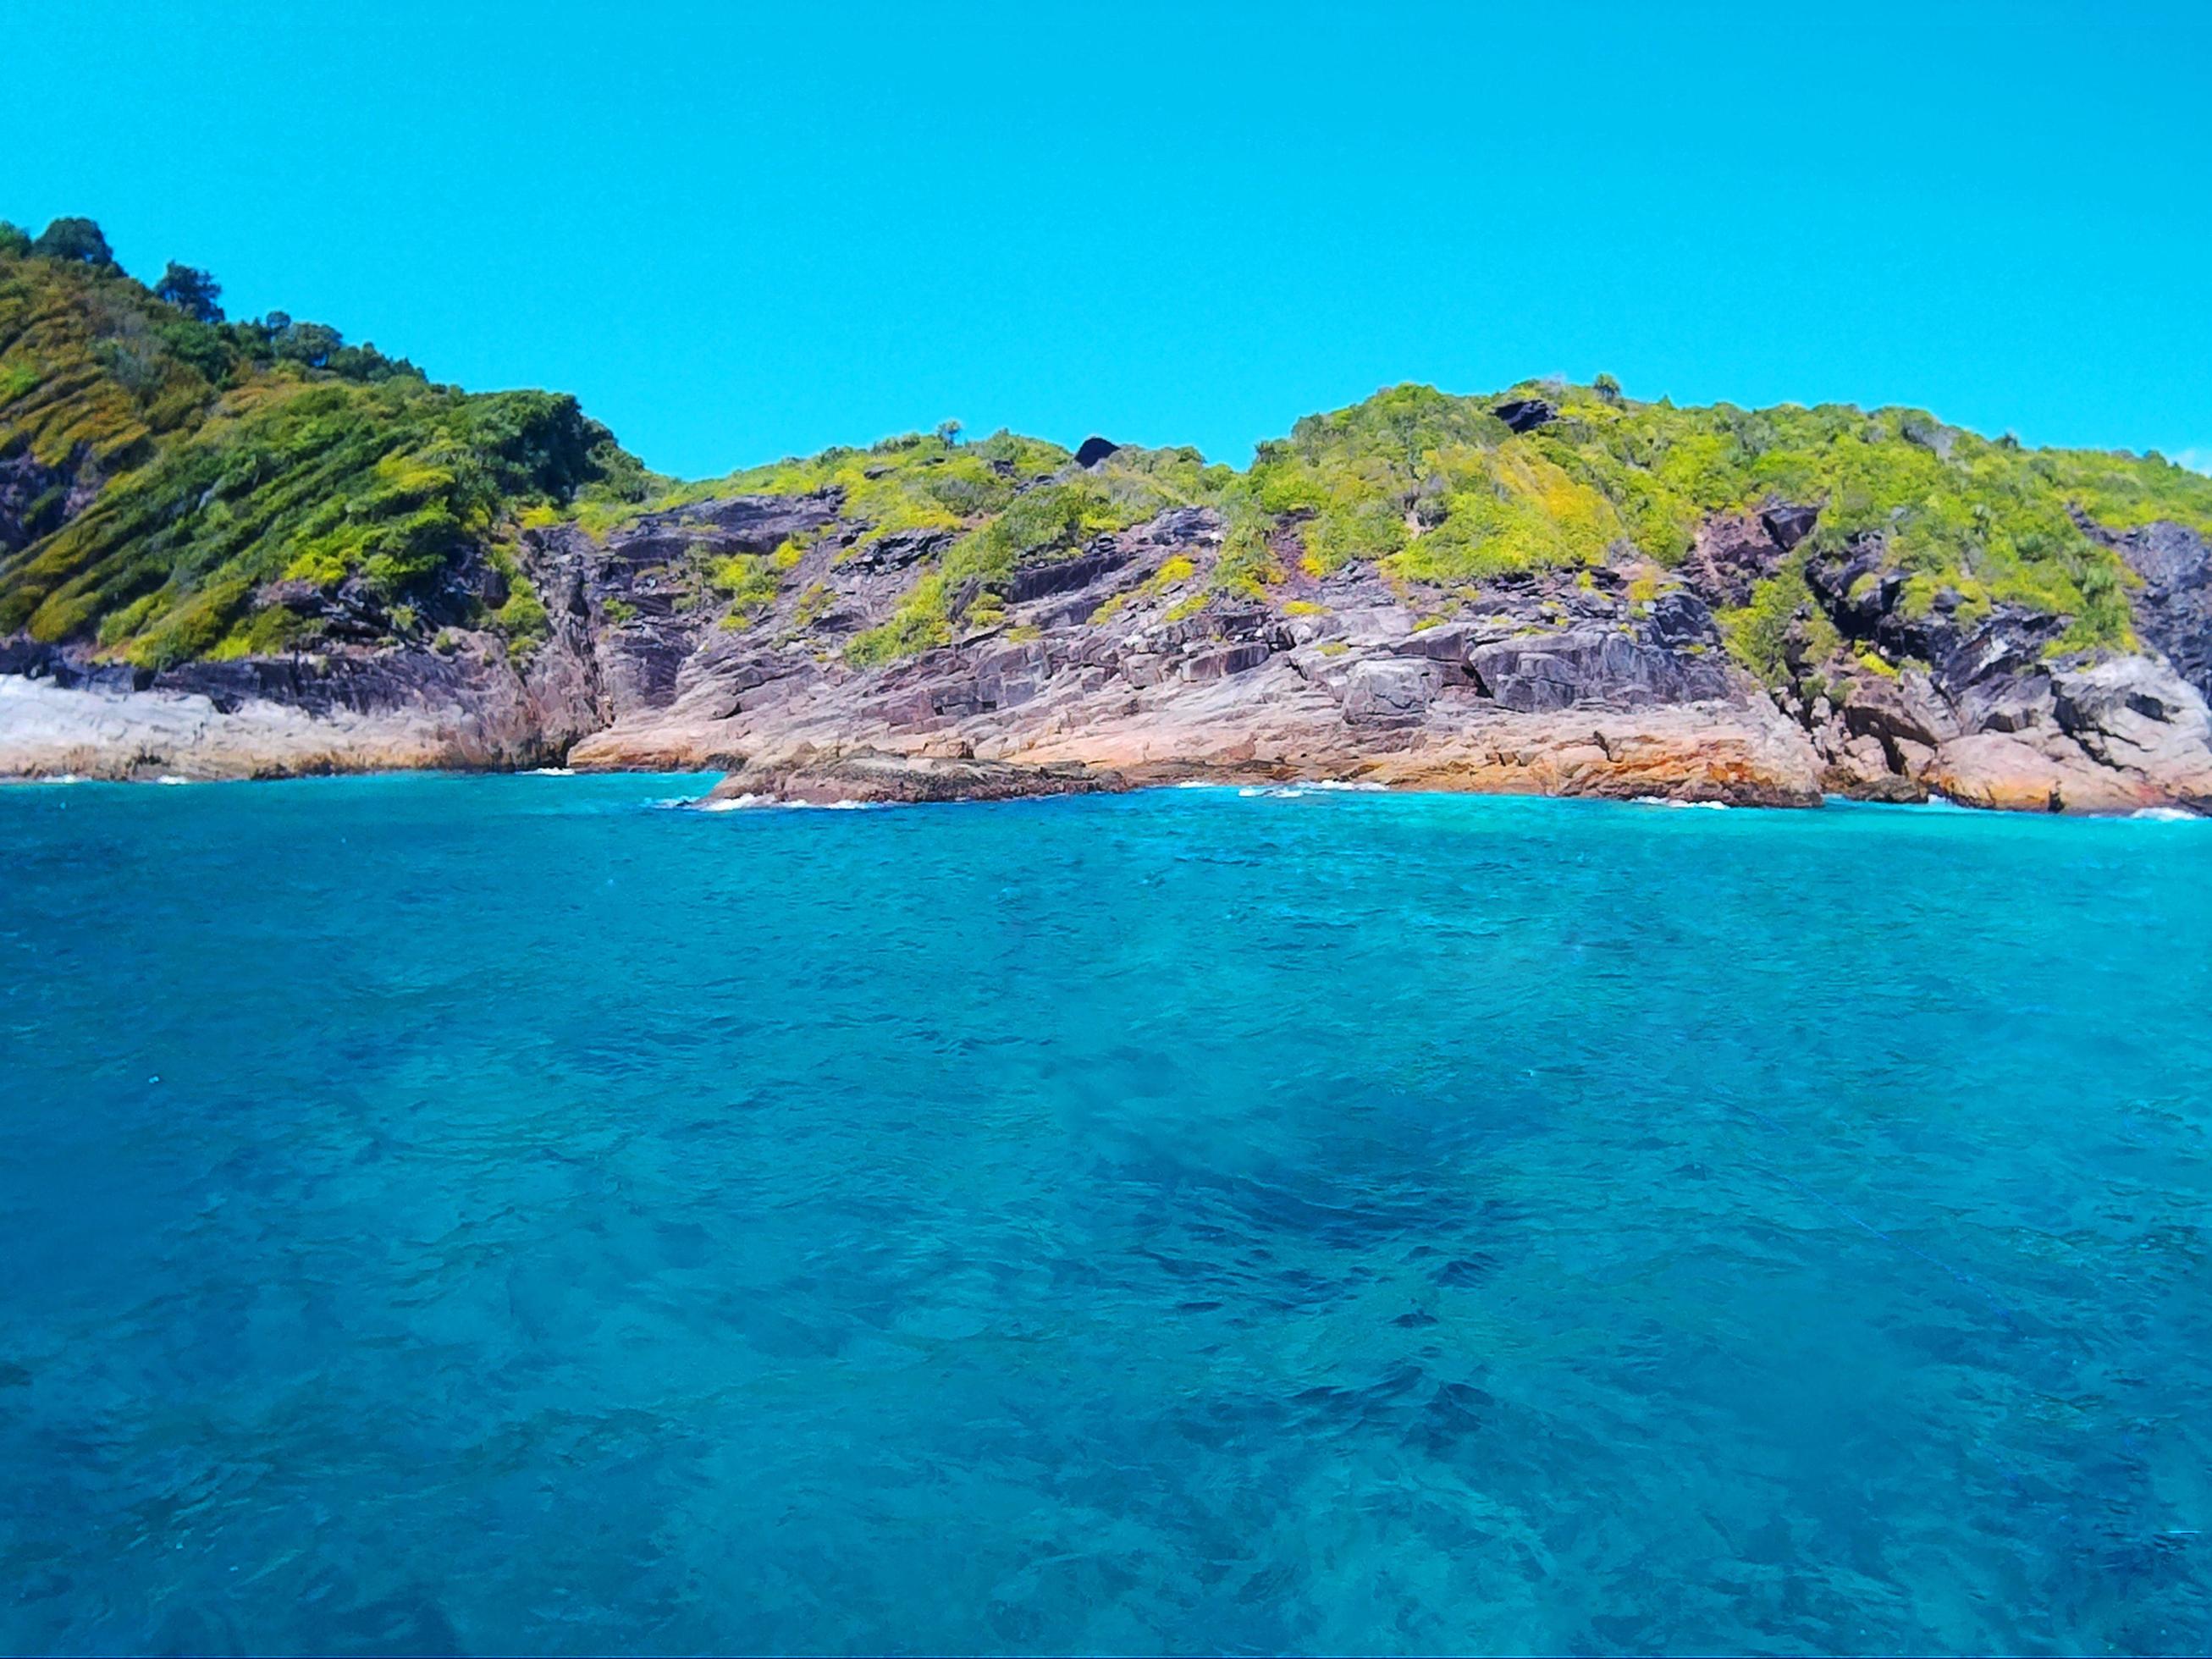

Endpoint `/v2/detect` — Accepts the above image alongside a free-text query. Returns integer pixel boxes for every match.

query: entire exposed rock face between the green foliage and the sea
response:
[13,491,2212,812]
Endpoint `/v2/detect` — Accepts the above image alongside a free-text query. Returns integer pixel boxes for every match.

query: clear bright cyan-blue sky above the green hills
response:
[17,0,2212,476]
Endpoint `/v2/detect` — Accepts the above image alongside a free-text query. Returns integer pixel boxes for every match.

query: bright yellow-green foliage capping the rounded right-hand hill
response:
[1249,383,2212,643]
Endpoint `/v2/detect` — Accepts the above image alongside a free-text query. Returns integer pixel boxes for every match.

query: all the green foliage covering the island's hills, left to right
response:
[0,219,2212,672]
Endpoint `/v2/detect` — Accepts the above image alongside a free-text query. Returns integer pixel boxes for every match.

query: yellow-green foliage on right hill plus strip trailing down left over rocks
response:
[823,387,2212,670]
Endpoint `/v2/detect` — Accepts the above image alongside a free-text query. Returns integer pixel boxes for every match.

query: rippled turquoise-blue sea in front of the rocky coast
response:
[0,776,2212,1652]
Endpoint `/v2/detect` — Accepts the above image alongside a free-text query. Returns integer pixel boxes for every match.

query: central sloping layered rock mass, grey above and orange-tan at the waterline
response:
[557,509,1818,805]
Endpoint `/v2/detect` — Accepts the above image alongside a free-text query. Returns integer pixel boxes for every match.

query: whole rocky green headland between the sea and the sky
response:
[0,237,2212,809]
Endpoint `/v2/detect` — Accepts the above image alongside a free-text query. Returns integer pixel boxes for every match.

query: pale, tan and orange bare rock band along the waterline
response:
[0,648,2212,816]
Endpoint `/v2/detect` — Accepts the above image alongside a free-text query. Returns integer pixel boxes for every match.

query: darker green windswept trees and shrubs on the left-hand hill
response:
[0,228,635,666]
